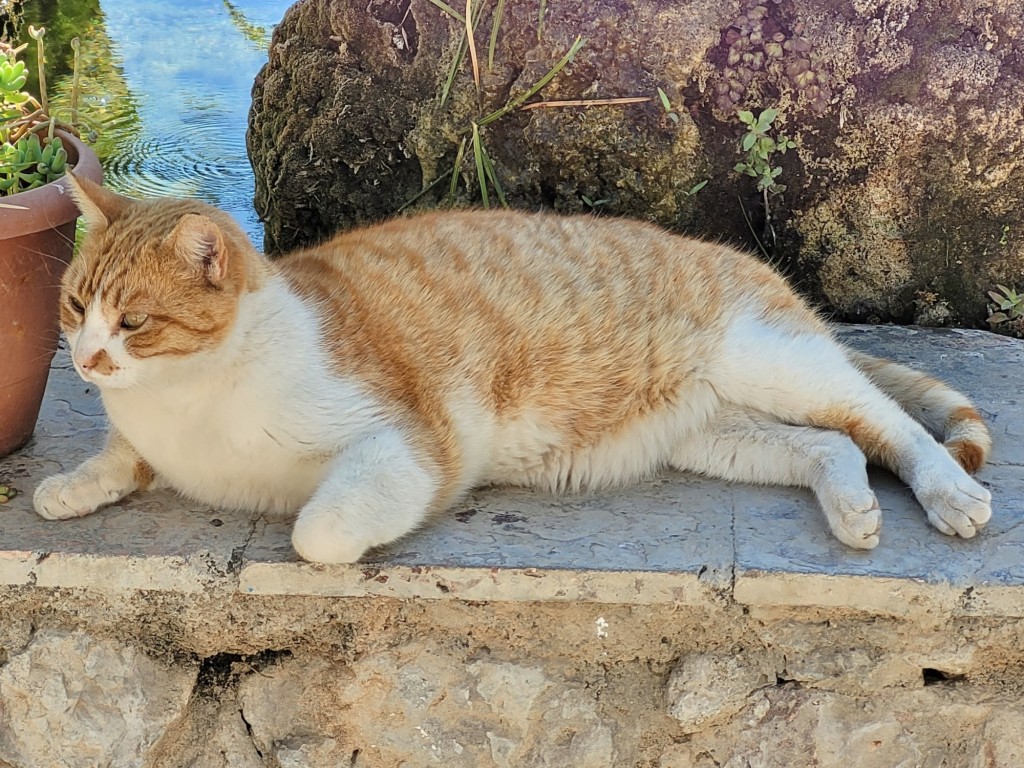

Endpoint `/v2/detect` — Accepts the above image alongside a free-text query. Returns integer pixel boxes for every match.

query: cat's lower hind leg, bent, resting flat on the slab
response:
[671,408,882,549]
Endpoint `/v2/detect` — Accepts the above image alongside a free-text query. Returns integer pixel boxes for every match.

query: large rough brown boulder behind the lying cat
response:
[249,0,1024,325]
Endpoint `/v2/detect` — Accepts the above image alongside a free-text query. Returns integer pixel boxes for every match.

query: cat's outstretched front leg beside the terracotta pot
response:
[32,427,156,520]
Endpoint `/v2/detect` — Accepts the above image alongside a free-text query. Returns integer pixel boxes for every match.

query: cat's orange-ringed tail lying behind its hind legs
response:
[846,348,992,472]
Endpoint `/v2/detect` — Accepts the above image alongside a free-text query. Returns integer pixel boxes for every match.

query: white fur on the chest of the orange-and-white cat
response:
[103,283,379,512]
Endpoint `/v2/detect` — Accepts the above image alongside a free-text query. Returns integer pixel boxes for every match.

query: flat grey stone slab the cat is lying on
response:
[0,326,1024,615]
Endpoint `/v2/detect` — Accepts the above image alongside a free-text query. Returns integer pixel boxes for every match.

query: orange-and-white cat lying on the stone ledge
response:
[34,178,991,563]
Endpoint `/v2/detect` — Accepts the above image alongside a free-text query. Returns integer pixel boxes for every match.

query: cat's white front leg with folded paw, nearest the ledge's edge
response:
[292,428,439,563]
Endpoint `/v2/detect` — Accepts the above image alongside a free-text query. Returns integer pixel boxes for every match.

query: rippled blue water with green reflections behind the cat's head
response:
[12,0,291,245]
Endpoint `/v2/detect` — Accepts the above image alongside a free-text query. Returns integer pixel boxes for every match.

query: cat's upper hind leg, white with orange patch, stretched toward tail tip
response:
[719,316,991,538]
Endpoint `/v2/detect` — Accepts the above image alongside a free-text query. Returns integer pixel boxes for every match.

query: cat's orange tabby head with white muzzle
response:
[60,177,262,389]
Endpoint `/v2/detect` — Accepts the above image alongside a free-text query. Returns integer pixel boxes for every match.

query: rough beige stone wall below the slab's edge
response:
[0,589,1024,768]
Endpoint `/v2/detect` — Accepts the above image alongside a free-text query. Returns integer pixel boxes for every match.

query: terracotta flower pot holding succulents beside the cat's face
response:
[0,131,103,457]
